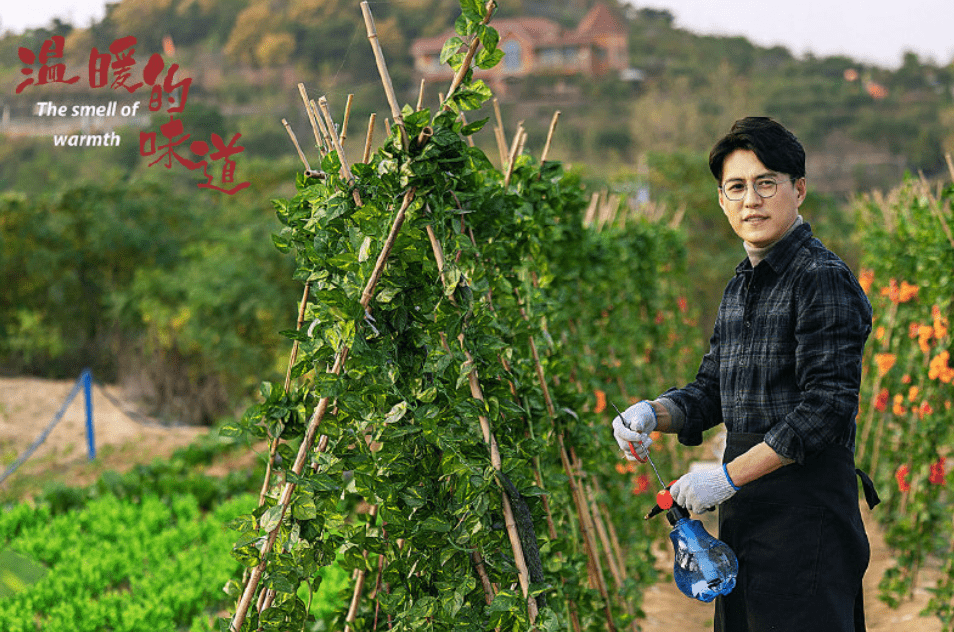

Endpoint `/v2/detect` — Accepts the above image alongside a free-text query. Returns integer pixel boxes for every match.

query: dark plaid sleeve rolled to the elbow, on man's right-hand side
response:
[765,262,871,463]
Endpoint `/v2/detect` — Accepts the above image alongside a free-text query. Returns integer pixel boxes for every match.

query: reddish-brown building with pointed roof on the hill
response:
[411,3,638,92]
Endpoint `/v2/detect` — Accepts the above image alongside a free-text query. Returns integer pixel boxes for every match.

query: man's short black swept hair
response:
[709,116,805,183]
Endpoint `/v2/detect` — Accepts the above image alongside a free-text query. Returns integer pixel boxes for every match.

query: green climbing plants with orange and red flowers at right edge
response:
[857,174,954,630]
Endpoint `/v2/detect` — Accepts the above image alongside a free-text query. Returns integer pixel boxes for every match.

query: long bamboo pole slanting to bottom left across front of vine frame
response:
[230,188,416,632]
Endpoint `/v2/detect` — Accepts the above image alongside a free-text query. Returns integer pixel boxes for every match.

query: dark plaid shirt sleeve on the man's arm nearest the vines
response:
[660,322,722,445]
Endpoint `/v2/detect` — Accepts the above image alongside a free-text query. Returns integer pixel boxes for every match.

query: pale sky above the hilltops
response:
[0,0,954,68]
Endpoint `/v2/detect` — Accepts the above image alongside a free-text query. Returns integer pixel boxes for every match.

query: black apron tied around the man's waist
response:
[715,432,877,632]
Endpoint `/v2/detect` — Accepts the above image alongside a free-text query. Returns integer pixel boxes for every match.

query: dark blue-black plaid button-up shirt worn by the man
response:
[663,223,871,463]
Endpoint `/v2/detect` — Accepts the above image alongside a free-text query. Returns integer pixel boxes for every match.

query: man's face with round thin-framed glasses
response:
[719,149,805,248]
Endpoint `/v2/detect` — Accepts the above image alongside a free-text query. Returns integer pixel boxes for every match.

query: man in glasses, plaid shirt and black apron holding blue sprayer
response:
[613,117,877,632]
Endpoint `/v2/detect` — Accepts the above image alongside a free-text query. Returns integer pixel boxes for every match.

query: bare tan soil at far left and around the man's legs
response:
[0,378,941,632]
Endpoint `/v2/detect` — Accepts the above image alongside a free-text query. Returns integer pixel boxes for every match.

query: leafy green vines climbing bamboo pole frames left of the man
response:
[221,0,700,632]
